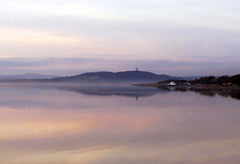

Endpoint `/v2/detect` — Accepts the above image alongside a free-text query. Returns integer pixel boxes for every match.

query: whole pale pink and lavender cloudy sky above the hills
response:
[0,0,240,76]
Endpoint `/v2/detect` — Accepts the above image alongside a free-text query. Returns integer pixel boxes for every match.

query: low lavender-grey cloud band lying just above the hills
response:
[0,58,239,76]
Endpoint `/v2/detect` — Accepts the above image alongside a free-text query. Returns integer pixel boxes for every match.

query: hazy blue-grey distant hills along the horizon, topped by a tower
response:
[0,71,198,82]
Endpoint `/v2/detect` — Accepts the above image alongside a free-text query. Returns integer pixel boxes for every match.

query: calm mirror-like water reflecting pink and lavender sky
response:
[0,84,240,164]
